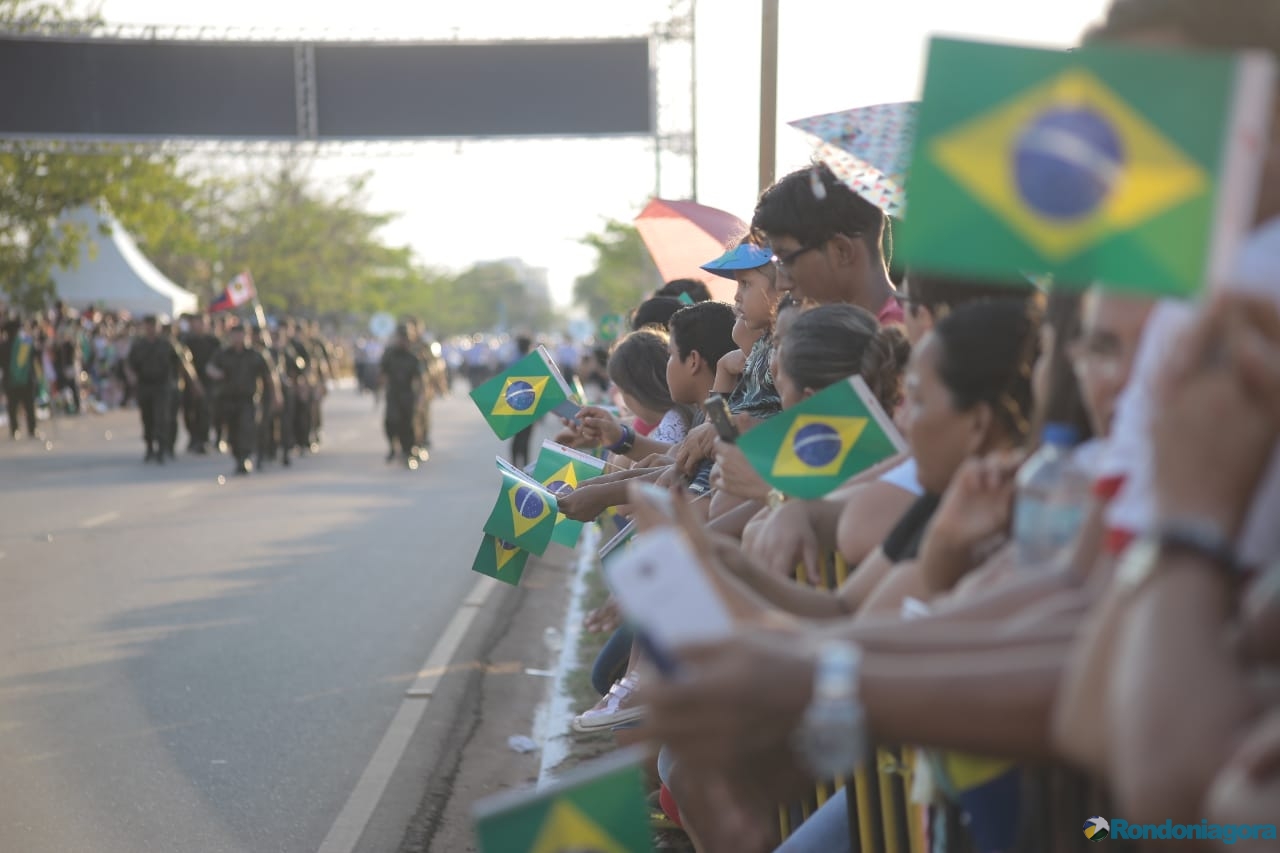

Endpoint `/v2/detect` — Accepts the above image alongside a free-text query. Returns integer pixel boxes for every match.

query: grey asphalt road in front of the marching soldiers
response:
[0,391,500,853]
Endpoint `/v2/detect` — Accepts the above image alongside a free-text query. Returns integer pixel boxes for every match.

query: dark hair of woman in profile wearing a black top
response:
[933,300,1039,442]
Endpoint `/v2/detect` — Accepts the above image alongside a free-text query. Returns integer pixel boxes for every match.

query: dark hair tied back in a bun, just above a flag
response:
[781,305,911,412]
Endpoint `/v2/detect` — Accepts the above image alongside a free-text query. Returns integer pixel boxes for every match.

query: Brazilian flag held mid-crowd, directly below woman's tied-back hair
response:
[737,377,906,500]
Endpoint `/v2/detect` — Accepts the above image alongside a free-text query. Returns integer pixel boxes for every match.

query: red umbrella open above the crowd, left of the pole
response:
[636,199,746,302]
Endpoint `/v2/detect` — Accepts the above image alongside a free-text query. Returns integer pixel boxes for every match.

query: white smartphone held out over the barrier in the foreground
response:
[604,528,733,650]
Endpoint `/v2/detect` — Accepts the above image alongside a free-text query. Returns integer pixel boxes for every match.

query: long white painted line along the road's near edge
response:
[316,578,498,853]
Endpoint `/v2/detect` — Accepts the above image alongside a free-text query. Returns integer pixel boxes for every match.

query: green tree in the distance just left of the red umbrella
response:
[573,219,662,319]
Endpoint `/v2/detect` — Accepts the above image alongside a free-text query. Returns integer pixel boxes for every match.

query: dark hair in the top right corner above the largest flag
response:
[1084,0,1280,54]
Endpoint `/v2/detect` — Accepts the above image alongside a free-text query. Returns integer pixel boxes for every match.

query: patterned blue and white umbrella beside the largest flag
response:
[790,101,920,216]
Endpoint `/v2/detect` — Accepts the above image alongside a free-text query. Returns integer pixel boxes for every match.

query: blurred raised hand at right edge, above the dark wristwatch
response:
[1152,293,1280,535]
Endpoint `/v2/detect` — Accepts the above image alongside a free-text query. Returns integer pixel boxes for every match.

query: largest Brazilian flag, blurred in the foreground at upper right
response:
[905,38,1274,296]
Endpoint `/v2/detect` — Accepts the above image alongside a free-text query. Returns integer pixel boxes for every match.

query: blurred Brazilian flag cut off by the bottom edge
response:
[474,749,653,853]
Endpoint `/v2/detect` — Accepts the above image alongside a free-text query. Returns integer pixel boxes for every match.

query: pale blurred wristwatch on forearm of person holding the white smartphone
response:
[794,642,867,779]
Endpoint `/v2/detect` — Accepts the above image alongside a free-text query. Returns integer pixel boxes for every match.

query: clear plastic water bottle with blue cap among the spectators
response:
[1014,424,1089,569]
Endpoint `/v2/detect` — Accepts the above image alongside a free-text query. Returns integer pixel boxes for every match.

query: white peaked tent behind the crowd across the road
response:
[54,206,197,316]
